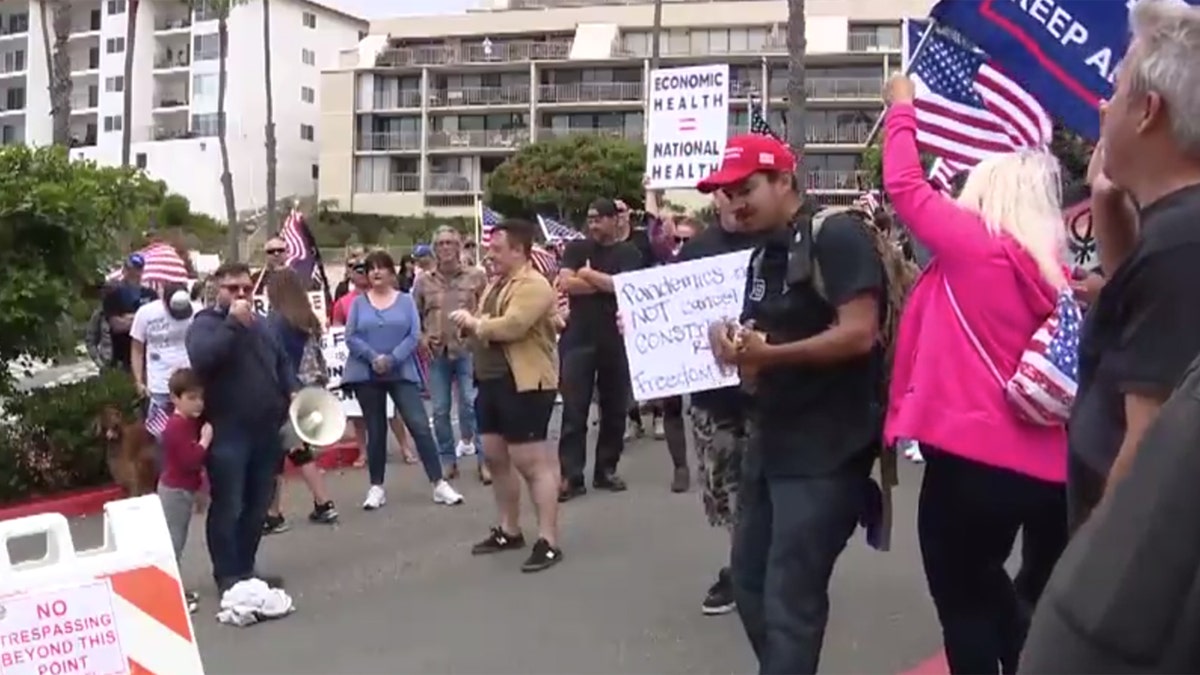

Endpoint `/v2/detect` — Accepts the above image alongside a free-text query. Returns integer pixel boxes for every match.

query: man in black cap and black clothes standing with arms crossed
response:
[558,199,642,501]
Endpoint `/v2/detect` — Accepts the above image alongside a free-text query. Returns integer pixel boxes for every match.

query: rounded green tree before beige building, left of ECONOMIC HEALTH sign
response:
[485,135,646,222]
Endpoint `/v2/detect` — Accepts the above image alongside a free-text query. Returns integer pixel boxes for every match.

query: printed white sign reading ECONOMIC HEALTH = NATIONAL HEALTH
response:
[646,64,730,190]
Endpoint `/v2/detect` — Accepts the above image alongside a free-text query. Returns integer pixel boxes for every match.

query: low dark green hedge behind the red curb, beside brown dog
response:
[0,371,139,504]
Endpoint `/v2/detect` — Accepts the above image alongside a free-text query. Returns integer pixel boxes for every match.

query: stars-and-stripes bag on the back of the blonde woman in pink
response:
[1006,288,1084,426]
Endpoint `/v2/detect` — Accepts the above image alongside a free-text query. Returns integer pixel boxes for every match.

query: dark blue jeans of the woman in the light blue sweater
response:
[354,380,442,485]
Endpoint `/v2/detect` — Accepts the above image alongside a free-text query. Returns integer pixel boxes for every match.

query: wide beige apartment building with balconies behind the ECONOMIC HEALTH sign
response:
[319,0,934,215]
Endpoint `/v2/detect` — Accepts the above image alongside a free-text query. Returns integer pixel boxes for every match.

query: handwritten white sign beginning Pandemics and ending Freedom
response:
[613,251,750,401]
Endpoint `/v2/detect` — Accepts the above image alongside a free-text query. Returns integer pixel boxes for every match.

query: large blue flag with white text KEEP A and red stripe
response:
[932,0,1200,141]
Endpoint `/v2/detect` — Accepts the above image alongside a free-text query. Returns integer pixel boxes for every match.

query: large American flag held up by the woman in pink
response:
[904,19,1051,190]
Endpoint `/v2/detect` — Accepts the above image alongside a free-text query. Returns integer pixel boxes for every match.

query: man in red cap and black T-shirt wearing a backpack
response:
[697,135,884,674]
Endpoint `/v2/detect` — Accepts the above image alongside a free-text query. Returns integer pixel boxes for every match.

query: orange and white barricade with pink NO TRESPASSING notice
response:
[0,495,204,675]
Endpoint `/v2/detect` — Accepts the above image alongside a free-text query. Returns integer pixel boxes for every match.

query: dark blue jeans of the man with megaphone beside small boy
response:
[204,423,284,587]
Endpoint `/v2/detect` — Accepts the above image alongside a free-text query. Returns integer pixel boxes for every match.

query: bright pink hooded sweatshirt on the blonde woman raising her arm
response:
[883,103,1067,483]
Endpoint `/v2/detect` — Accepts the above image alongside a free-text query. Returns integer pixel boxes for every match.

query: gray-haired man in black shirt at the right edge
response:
[1067,23,1200,528]
